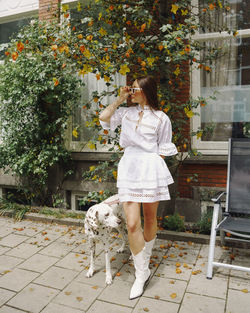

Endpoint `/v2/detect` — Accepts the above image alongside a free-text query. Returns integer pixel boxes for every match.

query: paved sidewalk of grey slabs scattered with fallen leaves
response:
[0,217,250,313]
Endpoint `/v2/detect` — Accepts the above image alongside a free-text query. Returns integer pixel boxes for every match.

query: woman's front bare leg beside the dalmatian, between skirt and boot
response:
[123,202,145,255]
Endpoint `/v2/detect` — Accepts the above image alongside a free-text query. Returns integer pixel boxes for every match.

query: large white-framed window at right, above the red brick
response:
[192,0,250,154]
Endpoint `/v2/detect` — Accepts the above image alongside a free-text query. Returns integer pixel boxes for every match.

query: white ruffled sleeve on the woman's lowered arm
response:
[158,114,178,156]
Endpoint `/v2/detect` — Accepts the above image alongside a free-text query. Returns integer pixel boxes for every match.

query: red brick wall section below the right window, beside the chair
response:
[178,163,227,198]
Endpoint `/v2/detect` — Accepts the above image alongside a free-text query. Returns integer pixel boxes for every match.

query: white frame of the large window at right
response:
[190,0,250,155]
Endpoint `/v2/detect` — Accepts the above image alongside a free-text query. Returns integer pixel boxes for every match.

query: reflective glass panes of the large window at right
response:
[200,0,250,141]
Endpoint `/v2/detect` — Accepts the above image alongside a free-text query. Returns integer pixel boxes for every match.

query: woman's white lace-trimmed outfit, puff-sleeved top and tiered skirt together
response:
[100,105,178,202]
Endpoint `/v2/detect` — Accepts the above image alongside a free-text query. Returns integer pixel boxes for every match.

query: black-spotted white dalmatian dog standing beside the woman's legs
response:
[84,195,126,285]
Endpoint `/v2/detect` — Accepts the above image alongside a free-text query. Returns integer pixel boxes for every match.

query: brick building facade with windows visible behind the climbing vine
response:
[0,0,250,221]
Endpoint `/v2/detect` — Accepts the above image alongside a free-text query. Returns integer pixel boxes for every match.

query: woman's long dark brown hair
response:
[137,76,159,110]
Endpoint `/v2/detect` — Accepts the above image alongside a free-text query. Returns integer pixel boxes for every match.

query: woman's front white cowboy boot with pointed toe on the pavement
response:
[129,247,151,300]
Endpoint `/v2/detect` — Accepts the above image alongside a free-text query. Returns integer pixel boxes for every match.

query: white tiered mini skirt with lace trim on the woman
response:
[117,147,174,203]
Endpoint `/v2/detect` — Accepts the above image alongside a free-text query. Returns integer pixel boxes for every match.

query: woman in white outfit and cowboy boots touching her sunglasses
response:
[100,76,177,299]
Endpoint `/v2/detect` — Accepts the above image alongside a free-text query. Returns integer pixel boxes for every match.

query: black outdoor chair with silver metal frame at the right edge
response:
[207,138,250,279]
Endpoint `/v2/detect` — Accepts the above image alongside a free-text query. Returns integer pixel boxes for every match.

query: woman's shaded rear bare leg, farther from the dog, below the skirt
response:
[142,202,159,242]
